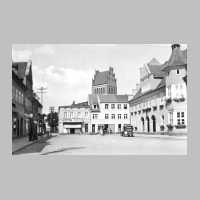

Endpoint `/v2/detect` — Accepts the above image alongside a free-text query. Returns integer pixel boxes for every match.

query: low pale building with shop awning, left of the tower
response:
[58,102,90,134]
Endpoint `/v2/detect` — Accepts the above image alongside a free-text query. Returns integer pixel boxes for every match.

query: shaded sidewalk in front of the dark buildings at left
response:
[12,134,48,153]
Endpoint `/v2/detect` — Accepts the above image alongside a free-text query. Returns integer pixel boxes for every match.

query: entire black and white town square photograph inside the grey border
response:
[11,43,189,156]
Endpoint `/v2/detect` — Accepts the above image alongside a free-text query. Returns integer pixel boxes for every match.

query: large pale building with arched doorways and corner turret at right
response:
[129,44,187,133]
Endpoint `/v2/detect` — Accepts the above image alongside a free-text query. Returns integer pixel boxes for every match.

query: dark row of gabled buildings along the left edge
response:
[12,61,42,138]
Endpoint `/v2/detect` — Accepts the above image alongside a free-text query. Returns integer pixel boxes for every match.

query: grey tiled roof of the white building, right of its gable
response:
[99,94,128,103]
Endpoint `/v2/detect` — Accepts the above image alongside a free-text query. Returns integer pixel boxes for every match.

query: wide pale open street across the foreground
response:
[14,135,187,155]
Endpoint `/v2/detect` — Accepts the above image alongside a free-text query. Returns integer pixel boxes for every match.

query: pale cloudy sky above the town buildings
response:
[12,44,186,113]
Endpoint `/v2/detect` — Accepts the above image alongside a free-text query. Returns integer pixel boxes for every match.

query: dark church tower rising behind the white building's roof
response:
[92,67,117,95]
